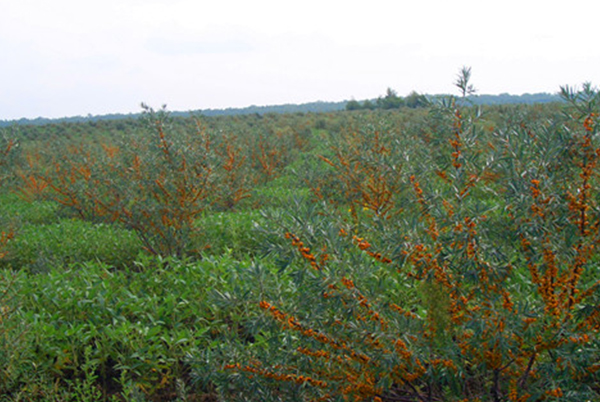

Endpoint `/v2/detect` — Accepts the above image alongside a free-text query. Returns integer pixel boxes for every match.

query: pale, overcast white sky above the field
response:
[0,0,600,120]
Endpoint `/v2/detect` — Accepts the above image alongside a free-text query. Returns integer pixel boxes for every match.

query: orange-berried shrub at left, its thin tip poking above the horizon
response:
[17,108,216,256]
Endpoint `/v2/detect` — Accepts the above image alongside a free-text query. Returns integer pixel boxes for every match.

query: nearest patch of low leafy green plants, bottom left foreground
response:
[0,256,272,400]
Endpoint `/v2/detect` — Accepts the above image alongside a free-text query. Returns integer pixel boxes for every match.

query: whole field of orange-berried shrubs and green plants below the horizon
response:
[0,77,600,402]
